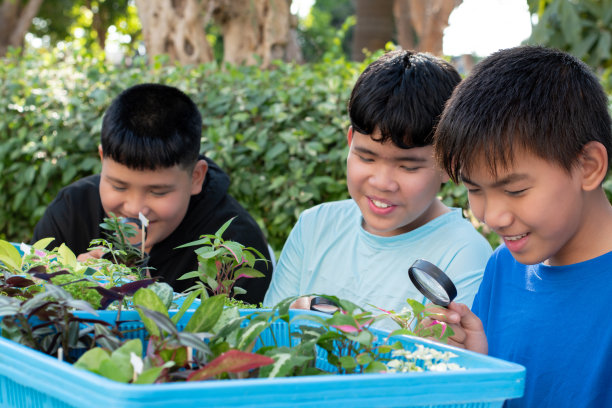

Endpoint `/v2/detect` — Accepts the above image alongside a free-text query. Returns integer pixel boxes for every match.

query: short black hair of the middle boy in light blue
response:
[348,50,461,149]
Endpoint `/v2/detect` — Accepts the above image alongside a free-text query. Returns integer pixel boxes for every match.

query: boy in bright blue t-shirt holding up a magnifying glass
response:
[434,46,612,408]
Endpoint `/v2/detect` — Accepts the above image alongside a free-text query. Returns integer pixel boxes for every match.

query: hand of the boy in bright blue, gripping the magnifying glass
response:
[428,302,489,354]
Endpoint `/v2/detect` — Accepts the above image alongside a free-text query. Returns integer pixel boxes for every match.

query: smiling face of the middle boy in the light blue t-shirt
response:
[347,128,448,236]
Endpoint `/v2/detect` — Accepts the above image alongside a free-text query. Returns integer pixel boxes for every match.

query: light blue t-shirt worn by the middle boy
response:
[263,200,492,311]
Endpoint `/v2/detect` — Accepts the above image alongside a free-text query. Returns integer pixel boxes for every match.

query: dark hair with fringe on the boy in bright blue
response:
[434,46,612,182]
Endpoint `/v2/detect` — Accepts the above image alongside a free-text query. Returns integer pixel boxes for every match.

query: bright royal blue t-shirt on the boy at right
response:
[472,245,612,408]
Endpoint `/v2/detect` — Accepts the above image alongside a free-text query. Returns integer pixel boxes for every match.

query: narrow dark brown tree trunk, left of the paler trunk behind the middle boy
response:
[352,0,394,61]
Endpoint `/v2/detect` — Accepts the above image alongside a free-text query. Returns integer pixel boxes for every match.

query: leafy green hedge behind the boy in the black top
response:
[0,50,364,249]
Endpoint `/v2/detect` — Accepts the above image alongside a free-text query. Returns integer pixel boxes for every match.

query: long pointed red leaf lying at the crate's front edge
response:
[187,350,274,381]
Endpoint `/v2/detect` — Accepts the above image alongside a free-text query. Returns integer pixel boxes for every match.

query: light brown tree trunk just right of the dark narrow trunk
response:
[394,0,463,56]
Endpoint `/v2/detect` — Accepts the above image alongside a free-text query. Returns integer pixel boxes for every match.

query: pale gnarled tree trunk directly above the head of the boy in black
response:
[136,0,214,64]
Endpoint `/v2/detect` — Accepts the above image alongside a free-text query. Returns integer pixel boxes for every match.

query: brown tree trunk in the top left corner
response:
[0,0,43,56]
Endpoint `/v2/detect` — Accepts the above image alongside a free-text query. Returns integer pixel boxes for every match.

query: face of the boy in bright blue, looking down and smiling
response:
[462,149,588,265]
